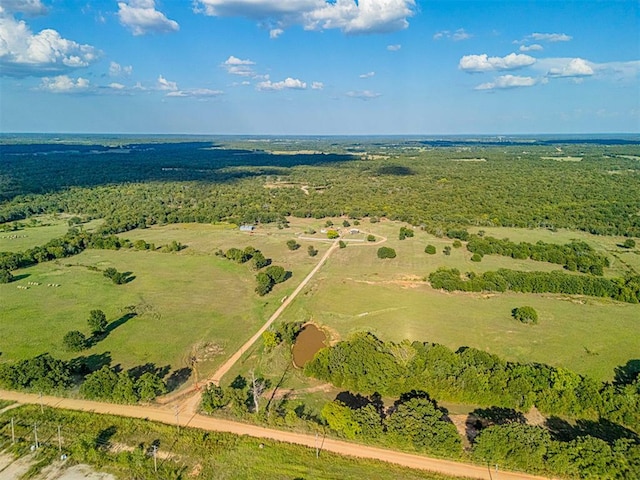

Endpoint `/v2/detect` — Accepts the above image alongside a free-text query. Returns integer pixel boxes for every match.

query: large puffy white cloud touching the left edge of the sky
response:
[0,9,99,77]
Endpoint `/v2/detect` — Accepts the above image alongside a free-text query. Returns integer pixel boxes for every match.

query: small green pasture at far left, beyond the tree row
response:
[0,215,102,252]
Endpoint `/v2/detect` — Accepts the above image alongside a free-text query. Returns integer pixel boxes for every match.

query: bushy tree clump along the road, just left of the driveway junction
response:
[80,365,167,403]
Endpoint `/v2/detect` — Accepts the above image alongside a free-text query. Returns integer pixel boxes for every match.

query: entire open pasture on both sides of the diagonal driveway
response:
[0,218,640,386]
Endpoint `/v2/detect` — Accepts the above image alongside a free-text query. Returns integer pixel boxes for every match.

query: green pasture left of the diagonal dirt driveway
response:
[0,225,326,382]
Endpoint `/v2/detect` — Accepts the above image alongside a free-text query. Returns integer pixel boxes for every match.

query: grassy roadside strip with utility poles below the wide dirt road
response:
[0,406,470,480]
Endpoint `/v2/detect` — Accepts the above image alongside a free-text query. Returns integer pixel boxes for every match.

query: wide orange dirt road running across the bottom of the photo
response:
[0,390,544,480]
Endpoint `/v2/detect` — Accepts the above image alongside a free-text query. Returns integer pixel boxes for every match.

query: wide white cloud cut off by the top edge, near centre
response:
[195,0,415,33]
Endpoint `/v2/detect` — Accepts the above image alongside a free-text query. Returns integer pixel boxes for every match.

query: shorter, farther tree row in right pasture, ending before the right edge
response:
[467,235,609,275]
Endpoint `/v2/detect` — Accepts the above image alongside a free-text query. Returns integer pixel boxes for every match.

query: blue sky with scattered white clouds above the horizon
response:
[0,0,640,135]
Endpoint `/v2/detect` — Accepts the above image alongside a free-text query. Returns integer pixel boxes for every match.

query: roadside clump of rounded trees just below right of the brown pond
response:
[321,392,462,457]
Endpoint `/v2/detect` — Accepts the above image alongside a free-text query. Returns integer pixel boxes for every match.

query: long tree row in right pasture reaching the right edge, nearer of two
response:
[429,267,640,303]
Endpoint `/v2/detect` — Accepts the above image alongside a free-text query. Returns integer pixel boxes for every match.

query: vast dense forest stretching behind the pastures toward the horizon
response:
[0,143,640,236]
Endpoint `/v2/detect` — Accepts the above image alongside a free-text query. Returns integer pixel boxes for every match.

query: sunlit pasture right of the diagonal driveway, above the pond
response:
[278,222,640,380]
